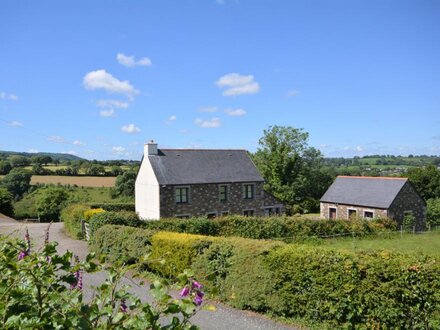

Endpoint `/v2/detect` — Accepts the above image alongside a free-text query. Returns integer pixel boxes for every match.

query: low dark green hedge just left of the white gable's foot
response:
[89,211,143,240]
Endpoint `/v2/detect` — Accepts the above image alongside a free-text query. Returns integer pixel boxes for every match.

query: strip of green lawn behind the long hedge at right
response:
[311,230,440,256]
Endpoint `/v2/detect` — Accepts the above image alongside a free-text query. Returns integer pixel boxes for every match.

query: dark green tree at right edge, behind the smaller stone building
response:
[406,165,440,201]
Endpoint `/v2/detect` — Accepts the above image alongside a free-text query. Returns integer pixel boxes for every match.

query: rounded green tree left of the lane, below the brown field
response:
[36,187,69,221]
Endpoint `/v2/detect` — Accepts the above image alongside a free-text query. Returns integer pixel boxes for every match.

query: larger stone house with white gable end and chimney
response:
[135,141,283,220]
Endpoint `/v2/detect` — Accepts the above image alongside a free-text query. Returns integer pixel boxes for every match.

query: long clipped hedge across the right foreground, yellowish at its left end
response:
[95,226,440,329]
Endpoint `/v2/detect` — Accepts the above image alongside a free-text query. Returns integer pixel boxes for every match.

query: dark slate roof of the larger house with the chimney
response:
[148,149,264,185]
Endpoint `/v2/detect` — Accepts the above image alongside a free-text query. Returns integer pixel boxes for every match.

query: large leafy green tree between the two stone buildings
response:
[253,126,333,212]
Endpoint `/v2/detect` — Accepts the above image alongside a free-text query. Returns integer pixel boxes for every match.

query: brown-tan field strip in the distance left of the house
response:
[31,175,116,188]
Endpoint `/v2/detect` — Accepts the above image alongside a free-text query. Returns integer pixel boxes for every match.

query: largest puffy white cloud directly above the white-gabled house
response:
[215,73,260,96]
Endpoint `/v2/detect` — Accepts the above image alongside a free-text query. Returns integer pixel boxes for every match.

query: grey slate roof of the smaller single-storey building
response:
[321,176,408,209]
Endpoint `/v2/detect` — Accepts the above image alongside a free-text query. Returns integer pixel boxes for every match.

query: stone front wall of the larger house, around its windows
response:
[160,182,276,218]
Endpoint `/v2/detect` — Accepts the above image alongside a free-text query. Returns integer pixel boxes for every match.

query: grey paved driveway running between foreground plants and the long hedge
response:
[0,214,298,330]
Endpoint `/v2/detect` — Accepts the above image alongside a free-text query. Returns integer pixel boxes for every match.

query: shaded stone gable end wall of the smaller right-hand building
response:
[389,182,426,231]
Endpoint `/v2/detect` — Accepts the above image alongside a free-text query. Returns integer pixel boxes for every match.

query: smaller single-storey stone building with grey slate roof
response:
[321,176,426,230]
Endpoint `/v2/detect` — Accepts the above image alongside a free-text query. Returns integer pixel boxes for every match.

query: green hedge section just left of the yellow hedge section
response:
[90,225,154,264]
